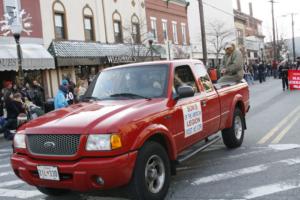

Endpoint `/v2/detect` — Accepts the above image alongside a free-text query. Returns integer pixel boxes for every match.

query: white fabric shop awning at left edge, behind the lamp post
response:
[0,44,55,71]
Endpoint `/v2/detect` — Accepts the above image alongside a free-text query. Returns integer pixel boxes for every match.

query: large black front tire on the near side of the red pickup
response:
[130,141,171,200]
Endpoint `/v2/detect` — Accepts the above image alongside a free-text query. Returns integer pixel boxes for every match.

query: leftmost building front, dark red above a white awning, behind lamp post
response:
[0,0,54,97]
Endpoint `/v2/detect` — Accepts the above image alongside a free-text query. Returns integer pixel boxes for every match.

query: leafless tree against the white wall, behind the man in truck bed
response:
[207,21,234,66]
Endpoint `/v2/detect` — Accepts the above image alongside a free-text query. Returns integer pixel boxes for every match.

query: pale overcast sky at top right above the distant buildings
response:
[232,0,300,41]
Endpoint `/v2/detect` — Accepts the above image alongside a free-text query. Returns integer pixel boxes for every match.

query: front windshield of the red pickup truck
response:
[87,65,168,100]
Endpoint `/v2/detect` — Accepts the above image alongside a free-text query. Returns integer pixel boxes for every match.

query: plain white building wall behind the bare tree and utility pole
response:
[188,0,236,66]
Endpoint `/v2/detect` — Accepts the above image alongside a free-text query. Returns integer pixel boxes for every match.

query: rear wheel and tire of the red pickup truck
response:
[222,108,245,149]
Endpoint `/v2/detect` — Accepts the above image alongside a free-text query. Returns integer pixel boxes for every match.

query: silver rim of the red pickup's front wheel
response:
[145,155,166,193]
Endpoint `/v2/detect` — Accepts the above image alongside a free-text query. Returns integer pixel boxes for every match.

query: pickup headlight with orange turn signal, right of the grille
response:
[85,134,122,151]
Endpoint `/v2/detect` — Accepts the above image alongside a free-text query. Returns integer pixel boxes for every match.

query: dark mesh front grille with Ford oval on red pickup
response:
[27,135,80,156]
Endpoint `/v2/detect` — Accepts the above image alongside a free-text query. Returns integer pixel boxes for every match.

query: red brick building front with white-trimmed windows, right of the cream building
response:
[145,0,190,59]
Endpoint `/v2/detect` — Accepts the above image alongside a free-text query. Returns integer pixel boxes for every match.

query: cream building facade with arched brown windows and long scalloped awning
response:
[40,0,150,96]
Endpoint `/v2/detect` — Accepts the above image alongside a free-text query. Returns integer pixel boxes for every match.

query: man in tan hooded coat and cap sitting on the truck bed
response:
[218,44,244,83]
